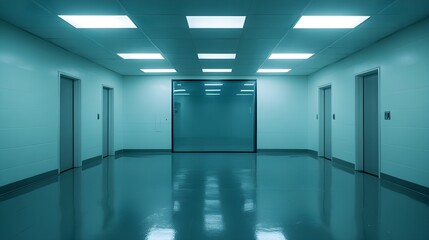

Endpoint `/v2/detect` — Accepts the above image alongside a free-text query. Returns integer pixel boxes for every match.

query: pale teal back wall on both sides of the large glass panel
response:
[123,76,308,149]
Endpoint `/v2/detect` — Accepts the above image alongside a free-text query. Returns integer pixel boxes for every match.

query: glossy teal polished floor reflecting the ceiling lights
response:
[0,153,429,240]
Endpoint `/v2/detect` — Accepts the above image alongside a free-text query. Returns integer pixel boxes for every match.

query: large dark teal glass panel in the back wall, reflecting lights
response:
[173,80,256,152]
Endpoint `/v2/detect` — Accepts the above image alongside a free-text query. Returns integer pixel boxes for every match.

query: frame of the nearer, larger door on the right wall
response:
[355,67,381,178]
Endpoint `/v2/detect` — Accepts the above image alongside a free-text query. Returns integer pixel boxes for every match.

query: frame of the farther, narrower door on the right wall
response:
[317,83,332,158]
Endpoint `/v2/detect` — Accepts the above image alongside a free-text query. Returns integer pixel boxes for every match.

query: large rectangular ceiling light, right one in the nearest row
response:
[293,16,369,28]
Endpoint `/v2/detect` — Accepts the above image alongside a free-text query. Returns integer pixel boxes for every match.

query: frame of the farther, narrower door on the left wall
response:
[100,84,115,157]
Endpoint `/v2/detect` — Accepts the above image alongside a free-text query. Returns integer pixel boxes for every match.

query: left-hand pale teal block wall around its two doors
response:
[0,21,122,186]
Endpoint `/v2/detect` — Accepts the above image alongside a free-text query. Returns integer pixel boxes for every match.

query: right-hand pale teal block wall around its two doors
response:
[308,20,429,187]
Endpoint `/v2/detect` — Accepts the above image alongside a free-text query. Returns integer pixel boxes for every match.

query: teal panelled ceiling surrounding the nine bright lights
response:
[0,0,429,76]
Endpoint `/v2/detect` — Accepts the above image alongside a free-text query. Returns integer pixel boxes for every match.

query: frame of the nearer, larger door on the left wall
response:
[57,71,82,174]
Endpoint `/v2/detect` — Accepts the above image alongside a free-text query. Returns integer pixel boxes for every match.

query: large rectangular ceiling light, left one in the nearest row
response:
[58,15,137,28]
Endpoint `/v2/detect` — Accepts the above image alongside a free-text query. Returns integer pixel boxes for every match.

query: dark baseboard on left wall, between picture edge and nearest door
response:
[0,169,58,200]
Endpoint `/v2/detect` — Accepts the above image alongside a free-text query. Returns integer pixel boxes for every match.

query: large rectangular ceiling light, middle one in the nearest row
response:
[186,16,246,28]
